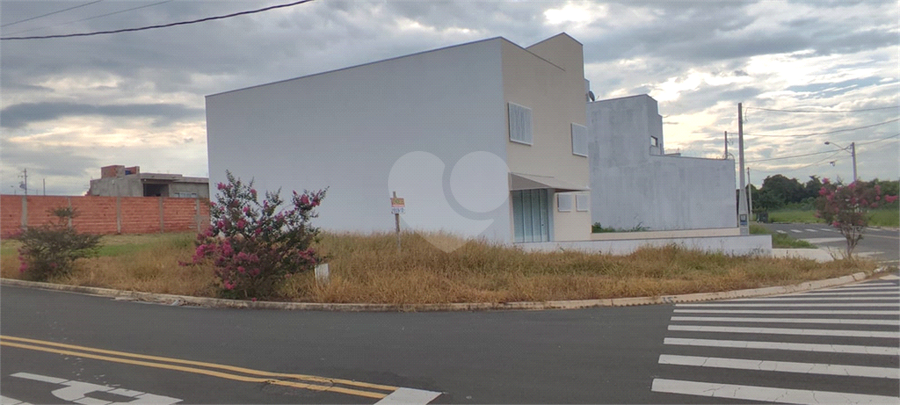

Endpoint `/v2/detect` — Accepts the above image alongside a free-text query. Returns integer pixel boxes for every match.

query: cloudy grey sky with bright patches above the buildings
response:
[0,0,900,195]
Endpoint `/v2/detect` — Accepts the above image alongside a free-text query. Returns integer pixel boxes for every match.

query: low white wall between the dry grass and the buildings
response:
[519,235,772,257]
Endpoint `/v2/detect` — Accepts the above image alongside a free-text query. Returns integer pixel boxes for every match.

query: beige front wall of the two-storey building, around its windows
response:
[502,34,591,241]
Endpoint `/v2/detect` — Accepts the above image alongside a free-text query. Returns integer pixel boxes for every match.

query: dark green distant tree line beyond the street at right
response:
[749,174,900,213]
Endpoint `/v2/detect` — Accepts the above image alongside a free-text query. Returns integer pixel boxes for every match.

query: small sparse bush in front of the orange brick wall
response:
[16,207,100,281]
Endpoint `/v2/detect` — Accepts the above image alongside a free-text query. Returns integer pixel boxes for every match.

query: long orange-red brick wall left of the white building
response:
[0,195,209,238]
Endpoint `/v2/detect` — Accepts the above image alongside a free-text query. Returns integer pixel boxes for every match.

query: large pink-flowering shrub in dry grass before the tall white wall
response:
[194,172,326,300]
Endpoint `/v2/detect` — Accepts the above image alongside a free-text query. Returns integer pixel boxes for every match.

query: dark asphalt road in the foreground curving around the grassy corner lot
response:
[0,281,900,405]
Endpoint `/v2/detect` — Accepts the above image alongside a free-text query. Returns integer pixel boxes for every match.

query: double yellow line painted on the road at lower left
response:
[0,336,397,399]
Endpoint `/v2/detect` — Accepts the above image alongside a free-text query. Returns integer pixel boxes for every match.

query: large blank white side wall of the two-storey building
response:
[206,39,511,242]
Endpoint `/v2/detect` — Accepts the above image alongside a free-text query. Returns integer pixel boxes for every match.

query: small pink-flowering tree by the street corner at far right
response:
[816,179,897,258]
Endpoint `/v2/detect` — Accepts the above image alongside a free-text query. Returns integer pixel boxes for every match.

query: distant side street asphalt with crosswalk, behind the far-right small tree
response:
[760,224,900,265]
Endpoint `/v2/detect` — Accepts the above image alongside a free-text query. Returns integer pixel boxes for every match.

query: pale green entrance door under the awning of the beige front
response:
[512,189,551,242]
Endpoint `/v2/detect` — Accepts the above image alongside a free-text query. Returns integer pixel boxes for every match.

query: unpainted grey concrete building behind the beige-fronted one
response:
[587,95,737,230]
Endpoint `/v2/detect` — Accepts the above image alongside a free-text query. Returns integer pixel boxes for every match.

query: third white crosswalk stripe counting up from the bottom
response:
[663,338,900,356]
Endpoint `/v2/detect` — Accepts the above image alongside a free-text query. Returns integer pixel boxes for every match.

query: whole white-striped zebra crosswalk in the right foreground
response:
[651,278,900,404]
